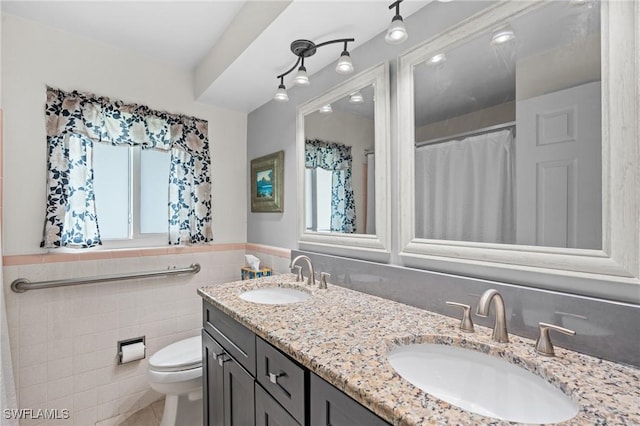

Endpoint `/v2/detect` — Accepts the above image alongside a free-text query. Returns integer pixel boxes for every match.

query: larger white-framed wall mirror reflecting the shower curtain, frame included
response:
[399,0,640,302]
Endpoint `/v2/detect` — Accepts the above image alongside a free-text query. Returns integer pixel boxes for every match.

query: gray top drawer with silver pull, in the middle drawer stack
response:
[256,337,309,424]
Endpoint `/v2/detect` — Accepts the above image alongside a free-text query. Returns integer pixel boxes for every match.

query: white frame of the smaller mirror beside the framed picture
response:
[296,62,391,260]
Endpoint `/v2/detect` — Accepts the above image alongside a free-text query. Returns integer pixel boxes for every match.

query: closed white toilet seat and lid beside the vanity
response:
[149,336,202,373]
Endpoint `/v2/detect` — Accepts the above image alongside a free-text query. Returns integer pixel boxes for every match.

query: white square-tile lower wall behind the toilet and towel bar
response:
[4,250,250,426]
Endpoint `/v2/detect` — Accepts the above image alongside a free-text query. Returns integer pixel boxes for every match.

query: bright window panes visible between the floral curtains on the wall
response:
[93,143,171,247]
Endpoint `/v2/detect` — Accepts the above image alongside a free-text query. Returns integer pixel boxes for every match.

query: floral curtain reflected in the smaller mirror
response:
[305,139,356,234]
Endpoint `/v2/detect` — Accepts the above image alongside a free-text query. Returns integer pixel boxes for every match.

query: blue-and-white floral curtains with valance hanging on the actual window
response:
[40,87,213,248]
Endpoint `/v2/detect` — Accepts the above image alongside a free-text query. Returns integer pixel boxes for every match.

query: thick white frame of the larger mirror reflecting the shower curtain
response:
[398,1,640,303]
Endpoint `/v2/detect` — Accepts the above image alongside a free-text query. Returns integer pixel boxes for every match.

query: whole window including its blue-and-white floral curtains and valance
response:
[40,87,213,249]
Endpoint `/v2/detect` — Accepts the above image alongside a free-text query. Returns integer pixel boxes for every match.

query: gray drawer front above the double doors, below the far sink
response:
[202,302,256,375]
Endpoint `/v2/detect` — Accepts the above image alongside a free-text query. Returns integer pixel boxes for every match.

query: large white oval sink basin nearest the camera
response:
[388,343,578,423]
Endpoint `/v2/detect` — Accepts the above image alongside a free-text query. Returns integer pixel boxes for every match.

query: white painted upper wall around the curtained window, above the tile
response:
[2,15,247,255]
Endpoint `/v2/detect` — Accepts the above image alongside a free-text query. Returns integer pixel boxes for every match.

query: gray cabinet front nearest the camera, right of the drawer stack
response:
[309,374,389,426]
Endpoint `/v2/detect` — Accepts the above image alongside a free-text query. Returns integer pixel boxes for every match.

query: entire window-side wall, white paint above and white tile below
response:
[0,11,250,425]
